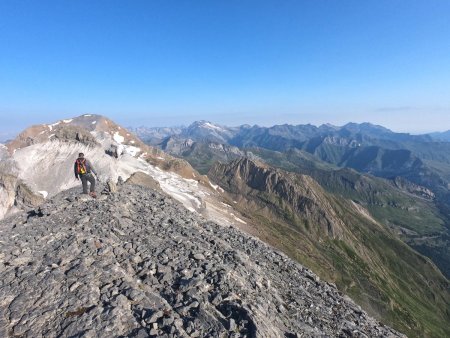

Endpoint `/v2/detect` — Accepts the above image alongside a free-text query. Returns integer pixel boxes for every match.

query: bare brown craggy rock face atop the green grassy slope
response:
[208,158,344,239]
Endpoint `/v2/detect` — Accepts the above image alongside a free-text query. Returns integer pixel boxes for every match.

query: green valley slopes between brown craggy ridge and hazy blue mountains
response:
[246,149,450,279]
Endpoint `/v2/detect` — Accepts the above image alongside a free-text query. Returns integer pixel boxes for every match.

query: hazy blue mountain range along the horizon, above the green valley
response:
[135,121,450,194]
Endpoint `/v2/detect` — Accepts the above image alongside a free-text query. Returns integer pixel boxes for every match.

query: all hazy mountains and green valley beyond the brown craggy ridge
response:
[132,121,450,277]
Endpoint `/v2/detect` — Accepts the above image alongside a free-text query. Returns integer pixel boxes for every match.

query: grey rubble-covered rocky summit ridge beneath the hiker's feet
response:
[0,185,400,338]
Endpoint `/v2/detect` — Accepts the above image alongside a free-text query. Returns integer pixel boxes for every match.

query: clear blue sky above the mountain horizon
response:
[0,0,450,139]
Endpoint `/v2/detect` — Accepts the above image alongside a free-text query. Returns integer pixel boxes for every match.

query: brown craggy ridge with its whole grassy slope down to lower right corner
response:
[208,159,450,337]
